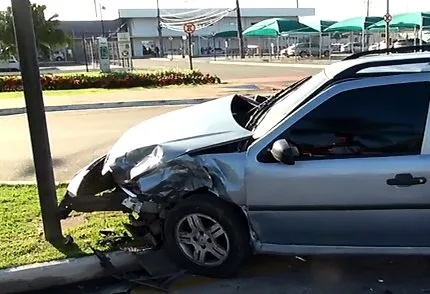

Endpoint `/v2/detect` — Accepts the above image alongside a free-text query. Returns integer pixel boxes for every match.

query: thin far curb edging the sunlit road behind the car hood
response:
[0,98,216,116]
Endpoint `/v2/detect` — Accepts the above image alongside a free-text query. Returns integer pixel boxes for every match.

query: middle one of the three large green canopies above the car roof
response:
[324,16,383,50]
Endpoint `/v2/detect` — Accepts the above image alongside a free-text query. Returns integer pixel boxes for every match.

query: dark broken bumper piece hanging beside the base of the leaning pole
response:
[59,190,131,219]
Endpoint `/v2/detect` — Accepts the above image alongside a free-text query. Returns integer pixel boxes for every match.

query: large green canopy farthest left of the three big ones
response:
[243,18,318,58]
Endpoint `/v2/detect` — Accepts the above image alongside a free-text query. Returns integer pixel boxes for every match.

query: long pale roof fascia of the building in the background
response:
[118,8,315,18]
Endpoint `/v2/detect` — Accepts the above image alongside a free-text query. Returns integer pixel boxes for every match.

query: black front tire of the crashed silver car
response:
[164,194,252,278]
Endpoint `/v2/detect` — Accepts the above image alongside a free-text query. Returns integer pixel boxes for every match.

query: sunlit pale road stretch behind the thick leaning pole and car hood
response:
[0,107,185,181]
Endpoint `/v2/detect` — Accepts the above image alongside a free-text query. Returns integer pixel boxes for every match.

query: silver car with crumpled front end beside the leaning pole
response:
[60,47,430,277]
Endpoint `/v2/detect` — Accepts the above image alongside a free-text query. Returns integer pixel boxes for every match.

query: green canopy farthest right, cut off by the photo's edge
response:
[369,12,430,45]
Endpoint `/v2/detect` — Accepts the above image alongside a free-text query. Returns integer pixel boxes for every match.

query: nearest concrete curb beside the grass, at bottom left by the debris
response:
[0,251,141,294]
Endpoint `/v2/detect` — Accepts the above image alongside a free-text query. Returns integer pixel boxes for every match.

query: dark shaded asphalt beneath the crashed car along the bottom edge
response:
[32,256,430,294]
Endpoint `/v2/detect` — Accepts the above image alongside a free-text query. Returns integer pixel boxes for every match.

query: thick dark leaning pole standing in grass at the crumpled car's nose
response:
[12,0,64,245]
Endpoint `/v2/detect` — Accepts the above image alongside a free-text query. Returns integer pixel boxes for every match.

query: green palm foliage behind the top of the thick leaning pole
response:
[0,4,71,58]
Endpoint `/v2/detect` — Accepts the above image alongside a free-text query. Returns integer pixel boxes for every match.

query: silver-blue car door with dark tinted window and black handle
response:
[246,74,430,252]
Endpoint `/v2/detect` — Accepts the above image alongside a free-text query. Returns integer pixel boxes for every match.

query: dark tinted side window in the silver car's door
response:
[284,83,430,159]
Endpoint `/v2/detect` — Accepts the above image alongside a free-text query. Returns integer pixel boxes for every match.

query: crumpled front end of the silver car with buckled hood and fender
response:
[60,96,258,276]
